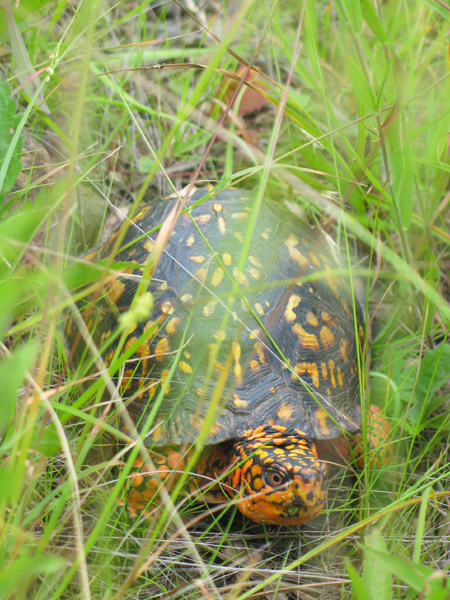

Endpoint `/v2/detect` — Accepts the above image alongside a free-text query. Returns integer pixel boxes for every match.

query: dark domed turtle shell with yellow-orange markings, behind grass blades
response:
[74,188,364,445]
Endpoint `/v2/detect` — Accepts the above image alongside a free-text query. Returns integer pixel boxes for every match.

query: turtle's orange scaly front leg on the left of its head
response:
[123,446,189,519]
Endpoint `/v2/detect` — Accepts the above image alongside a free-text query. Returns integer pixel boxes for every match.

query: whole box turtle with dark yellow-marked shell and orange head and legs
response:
[67,188,390,526]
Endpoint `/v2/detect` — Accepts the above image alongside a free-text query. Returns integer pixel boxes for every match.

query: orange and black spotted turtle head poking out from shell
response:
[228,425,327,526]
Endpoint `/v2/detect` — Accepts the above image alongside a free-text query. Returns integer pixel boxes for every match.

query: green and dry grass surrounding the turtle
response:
[0,0,450,600]
